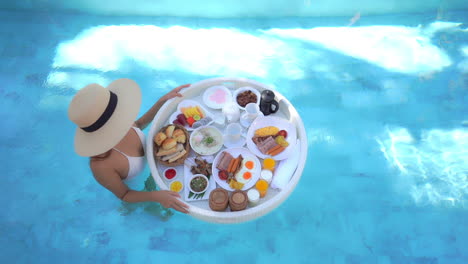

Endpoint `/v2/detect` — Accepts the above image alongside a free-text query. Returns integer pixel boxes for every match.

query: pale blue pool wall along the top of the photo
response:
[0,0,468,18]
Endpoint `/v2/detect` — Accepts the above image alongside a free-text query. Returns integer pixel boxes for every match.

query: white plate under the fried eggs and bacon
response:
[211,148,262,191]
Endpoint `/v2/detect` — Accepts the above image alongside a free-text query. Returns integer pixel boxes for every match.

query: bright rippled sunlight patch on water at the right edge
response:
[376,128,468,207]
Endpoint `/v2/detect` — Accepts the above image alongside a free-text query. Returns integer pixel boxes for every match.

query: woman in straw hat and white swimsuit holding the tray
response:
[68,79,190,213]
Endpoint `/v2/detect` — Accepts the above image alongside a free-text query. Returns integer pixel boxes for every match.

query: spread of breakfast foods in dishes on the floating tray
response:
[153,83,296,212]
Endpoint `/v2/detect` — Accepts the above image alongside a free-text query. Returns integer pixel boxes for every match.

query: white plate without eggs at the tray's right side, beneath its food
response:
[247,116,297,160]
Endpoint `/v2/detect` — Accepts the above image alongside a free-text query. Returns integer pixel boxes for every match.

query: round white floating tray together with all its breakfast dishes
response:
[146,78,308,224]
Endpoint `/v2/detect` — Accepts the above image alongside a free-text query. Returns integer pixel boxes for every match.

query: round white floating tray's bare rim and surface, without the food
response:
[146,77,308,223]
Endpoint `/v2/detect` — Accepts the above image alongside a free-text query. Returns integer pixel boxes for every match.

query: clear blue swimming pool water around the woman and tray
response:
[0,1,468,263]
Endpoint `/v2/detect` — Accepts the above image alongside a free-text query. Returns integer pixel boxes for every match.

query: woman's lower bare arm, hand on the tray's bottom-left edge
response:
[91,165,188,213]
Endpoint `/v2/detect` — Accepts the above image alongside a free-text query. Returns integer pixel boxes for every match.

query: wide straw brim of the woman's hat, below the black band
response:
[75,79,141,157]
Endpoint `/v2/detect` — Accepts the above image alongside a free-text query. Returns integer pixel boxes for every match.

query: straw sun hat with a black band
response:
[68,79,141,157]
